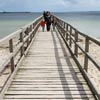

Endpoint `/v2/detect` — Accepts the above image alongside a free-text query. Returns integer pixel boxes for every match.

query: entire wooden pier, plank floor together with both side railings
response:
[0,17,100,100]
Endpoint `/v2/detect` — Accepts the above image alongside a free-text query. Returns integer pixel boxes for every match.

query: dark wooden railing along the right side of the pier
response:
[54,16,100,100]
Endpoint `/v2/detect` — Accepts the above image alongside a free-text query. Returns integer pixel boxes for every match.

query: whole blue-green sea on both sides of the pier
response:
[0,11,100,39]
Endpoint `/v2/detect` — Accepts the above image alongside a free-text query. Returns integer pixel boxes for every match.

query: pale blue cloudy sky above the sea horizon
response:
[0,0,100,12]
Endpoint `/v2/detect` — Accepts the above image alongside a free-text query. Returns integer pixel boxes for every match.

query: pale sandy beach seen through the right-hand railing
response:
[79,39,100,93]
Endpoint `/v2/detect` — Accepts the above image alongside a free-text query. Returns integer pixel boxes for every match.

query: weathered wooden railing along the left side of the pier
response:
[0,16,43,96]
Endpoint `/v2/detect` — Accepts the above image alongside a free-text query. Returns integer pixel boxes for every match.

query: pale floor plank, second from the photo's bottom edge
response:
[6,90,92,95]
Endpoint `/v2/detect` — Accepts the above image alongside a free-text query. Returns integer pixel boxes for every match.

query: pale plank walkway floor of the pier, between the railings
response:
[4,29,95,100]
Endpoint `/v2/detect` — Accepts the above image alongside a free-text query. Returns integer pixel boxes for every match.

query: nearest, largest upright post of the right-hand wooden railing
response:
[84,37,89,71]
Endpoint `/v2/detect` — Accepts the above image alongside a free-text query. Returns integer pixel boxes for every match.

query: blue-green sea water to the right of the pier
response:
[56,12,100,37]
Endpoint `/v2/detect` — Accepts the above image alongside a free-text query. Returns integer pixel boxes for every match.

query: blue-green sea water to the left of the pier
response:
[0,13,41,38]
